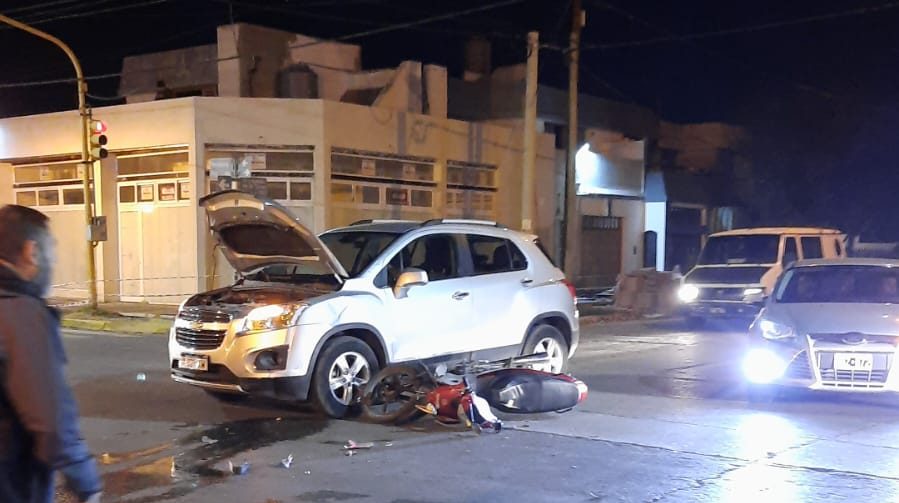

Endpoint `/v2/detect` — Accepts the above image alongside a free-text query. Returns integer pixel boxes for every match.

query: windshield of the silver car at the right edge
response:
[777,265,899,304]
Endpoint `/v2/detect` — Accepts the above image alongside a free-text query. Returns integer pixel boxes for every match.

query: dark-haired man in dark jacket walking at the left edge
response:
[0,205,101,503]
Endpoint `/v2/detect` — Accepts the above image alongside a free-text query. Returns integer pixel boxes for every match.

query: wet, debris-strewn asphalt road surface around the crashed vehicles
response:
[58,322,899,503]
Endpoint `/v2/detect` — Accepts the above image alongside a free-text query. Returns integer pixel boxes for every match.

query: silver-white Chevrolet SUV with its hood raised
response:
[169,191,578,417]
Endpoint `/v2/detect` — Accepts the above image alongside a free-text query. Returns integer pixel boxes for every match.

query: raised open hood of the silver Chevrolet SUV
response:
[200,190,347,281]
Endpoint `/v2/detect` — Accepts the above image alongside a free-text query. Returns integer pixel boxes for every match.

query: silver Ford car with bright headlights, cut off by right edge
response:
[743,259,899,396]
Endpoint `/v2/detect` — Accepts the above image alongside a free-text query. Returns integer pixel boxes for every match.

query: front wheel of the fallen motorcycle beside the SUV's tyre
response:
[361,365,428,424]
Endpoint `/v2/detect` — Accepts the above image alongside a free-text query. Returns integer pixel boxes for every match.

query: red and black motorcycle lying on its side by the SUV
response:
[361,353,587,432]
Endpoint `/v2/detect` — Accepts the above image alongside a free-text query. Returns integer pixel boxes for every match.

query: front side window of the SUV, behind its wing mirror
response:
[374,234,459,288]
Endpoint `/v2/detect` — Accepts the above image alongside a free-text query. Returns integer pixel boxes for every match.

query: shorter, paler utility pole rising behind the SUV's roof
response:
[521,31,540,232]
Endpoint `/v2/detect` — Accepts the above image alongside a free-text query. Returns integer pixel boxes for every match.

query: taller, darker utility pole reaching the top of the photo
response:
[559,0,586,277]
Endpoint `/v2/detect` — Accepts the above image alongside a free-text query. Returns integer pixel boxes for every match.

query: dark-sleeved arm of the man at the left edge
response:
[2,298,101,501]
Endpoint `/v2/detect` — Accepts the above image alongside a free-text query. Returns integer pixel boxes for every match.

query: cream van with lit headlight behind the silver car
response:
[678,227,846,326]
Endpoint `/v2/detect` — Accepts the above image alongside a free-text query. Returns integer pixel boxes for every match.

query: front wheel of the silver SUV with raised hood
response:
[312,336,378,418]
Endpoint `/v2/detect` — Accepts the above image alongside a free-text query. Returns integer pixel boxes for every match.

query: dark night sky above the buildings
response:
[0,0,899,235]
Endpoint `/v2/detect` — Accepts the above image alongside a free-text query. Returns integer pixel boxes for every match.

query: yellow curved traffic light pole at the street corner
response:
[0,14,97,309]
